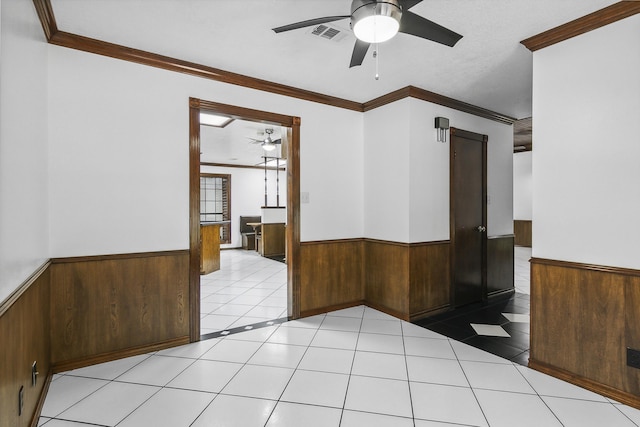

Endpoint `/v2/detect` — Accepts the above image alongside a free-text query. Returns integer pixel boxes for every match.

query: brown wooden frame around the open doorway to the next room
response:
[189,98,301,342]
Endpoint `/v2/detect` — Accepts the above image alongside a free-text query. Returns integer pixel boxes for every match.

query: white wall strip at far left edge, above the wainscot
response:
[0,0,49,302]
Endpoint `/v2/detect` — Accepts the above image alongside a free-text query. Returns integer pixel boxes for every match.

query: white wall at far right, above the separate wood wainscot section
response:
[533,15,640,269]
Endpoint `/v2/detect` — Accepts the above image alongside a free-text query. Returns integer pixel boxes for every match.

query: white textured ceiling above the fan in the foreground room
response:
[52,0,616,118]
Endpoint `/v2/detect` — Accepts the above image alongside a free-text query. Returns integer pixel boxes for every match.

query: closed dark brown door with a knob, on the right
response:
[450,128,487,307]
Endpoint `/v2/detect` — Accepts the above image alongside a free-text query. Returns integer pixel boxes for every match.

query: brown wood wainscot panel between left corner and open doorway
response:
[51,251,189,367]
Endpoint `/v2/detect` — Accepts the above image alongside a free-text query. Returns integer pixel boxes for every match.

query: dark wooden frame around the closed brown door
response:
[449,127,489,308]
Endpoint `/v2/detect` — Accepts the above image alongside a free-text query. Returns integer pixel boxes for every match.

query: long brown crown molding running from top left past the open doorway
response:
[33,0,516,124]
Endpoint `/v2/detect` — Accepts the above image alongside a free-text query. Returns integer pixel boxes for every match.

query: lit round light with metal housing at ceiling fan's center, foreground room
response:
[351,0,402,43]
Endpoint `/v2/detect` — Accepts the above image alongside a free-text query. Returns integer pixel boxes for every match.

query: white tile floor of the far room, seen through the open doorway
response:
[200,249,287,335]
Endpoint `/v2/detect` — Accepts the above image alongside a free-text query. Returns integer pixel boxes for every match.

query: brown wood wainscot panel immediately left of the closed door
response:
[409,242,451,321]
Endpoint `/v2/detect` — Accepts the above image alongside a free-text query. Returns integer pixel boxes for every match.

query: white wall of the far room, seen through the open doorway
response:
[200,166,287,248]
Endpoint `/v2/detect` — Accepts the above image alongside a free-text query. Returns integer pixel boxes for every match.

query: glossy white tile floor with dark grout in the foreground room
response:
[39,306,640,427]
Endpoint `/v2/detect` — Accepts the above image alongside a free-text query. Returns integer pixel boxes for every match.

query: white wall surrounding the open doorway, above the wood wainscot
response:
[49,46,363,257]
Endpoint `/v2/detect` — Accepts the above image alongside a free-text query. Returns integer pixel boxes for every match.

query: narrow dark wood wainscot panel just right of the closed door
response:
[487,235,514,297]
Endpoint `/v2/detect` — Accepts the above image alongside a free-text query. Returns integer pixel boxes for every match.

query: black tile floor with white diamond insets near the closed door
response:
[415,293,529,366]
